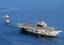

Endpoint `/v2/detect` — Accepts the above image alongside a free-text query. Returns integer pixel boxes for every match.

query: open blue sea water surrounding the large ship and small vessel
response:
[0,0,64,45]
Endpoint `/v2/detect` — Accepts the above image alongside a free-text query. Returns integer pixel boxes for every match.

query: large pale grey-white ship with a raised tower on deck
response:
[17,21,62,37]
